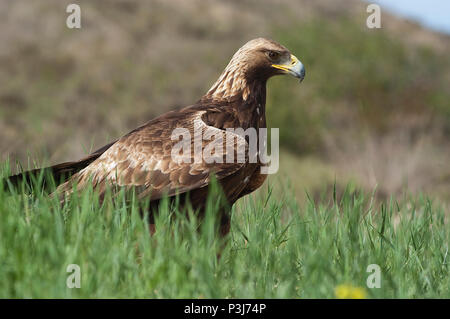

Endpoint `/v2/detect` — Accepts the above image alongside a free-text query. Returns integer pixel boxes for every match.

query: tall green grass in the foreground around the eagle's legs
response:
[0,168,450,298]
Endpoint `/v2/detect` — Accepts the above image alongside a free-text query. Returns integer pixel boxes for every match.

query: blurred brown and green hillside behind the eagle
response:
[0,0,450,207]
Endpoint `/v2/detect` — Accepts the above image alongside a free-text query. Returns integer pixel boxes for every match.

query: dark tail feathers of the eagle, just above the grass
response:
[3,141,116,189]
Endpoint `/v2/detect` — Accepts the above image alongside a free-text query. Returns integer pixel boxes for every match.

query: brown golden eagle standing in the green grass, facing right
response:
[8,38,305,235]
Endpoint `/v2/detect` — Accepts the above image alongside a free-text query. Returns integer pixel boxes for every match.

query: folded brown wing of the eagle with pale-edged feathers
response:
[59,111,248,199]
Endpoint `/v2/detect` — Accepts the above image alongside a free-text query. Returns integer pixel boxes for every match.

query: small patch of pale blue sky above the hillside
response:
[365,0,450,34]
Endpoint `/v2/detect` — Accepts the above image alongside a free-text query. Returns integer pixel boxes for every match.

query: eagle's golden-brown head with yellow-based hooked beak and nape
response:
[207,38,305,100]
